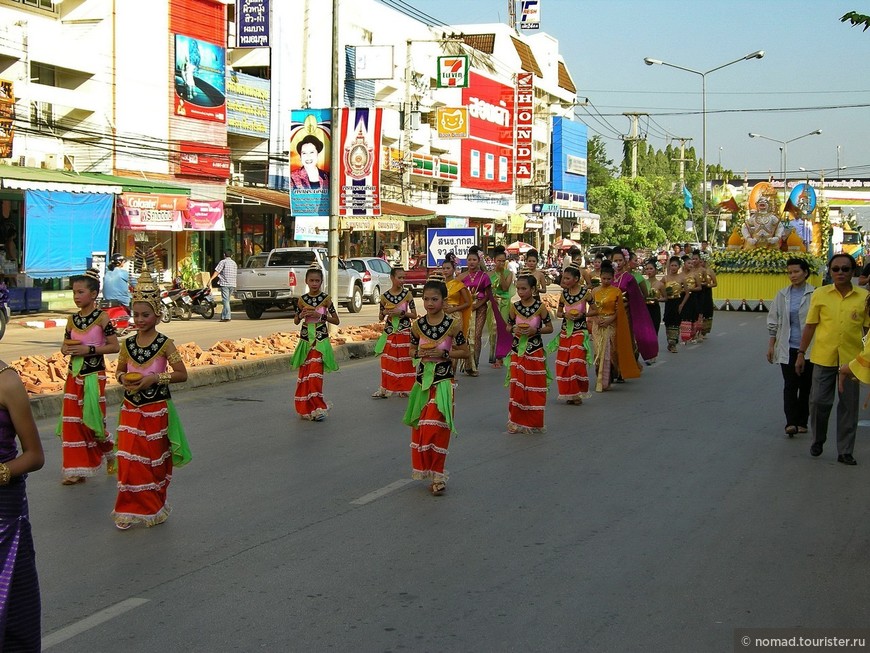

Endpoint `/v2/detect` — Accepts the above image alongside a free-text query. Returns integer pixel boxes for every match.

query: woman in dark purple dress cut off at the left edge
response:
[0,361,45,652]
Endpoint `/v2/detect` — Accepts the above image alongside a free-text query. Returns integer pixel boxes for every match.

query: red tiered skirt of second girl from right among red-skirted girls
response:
[508,349,547,433]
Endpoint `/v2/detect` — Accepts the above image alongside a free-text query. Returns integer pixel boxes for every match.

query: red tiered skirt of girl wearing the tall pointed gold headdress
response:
[112,399,172,526]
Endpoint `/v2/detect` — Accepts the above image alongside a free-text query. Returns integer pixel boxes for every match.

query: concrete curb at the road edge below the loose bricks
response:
[30,340,376,419]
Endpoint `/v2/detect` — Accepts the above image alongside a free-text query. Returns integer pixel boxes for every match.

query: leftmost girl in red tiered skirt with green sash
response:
[57,269,119,485]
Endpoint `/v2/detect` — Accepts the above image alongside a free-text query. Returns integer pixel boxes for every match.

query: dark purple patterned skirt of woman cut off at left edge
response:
[0,478,42,653]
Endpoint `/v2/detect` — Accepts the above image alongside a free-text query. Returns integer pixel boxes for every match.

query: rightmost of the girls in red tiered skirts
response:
[550,263,592,405]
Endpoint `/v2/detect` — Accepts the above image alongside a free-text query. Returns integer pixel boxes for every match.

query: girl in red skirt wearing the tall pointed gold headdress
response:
[112,271,191,530]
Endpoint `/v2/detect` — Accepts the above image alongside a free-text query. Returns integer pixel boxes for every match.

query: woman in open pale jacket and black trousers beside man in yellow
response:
[767,258,815,438]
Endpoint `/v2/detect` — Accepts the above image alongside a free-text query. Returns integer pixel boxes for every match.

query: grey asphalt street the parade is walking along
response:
[28,313,870,653]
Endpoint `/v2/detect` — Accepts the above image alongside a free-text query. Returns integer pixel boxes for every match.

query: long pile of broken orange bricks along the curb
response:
[11,324,384,394]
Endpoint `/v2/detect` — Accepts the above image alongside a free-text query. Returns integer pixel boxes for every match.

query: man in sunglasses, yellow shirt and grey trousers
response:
[795,253,870,465]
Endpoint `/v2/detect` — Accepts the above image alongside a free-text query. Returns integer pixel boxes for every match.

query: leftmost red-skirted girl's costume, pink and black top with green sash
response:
[56,309,115,478]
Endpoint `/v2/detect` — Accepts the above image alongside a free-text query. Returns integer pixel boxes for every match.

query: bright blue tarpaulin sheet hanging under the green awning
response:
[24,190,115,279]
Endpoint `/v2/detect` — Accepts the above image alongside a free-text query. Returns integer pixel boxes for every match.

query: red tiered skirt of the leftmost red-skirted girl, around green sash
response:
[61,372,115,478]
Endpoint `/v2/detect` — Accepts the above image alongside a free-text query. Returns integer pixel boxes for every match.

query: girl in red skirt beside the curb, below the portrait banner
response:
[291,263,339,422]
